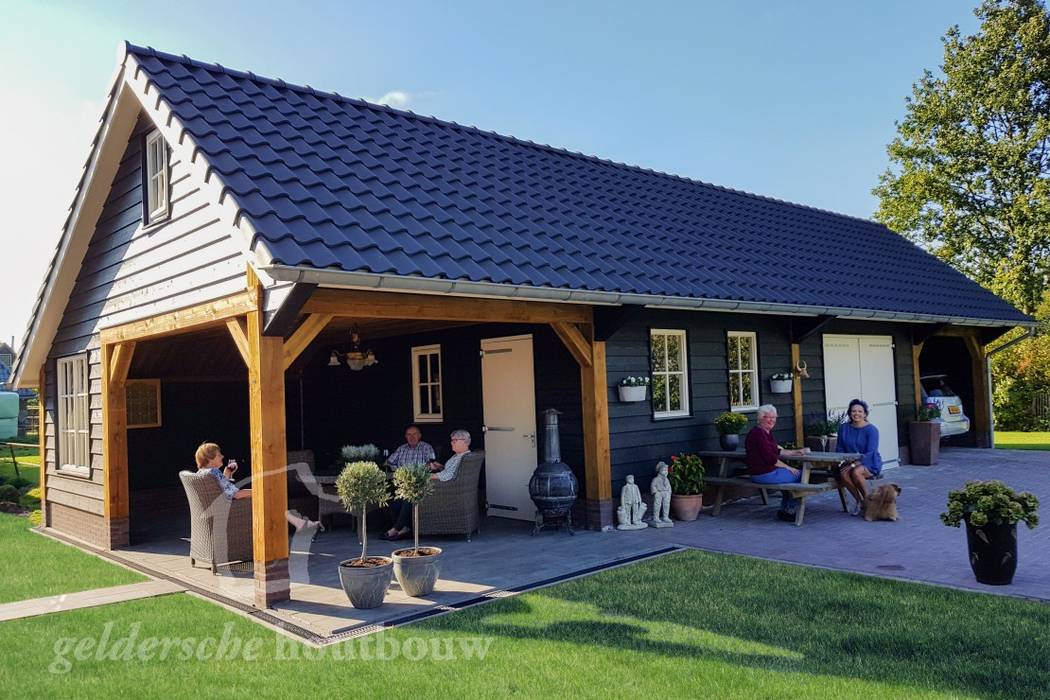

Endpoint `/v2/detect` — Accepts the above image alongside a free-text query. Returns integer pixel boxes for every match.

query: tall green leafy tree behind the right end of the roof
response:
[874,0,1050,313]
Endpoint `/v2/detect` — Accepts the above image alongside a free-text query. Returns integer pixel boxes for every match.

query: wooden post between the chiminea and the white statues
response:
[580,328,613,528]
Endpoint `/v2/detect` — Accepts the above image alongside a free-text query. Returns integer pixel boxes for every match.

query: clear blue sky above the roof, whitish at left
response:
[0,0,977,350]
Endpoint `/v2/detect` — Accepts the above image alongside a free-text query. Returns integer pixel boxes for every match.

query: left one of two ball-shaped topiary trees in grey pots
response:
[335,462,394,609]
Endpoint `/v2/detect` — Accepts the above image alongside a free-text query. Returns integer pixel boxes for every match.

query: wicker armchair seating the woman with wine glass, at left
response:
[179,470,252,573]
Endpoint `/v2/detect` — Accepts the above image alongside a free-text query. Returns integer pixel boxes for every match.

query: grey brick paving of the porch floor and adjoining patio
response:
[96,448,1050,642]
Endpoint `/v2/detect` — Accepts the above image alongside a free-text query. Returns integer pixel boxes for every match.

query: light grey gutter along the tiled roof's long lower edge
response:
[264,264,1030,327]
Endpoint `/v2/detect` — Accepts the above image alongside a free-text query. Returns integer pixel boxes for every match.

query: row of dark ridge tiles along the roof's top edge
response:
[125,42,897,227]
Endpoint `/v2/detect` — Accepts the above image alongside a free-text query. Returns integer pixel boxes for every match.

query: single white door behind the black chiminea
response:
[481,336,538,521]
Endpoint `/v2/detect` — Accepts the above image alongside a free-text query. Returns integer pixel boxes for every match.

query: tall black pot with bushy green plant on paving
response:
[941,481,1040,586]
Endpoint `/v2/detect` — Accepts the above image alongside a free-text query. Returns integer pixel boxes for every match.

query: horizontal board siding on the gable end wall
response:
[42,115,245,537]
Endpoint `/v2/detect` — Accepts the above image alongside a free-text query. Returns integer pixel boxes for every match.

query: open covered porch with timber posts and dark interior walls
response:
[101,271,612,608]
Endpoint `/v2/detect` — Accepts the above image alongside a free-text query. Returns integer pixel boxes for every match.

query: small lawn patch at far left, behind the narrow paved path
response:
[0,514,146,603]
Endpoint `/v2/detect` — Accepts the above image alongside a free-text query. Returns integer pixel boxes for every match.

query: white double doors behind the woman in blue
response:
[824,335,900,463]
